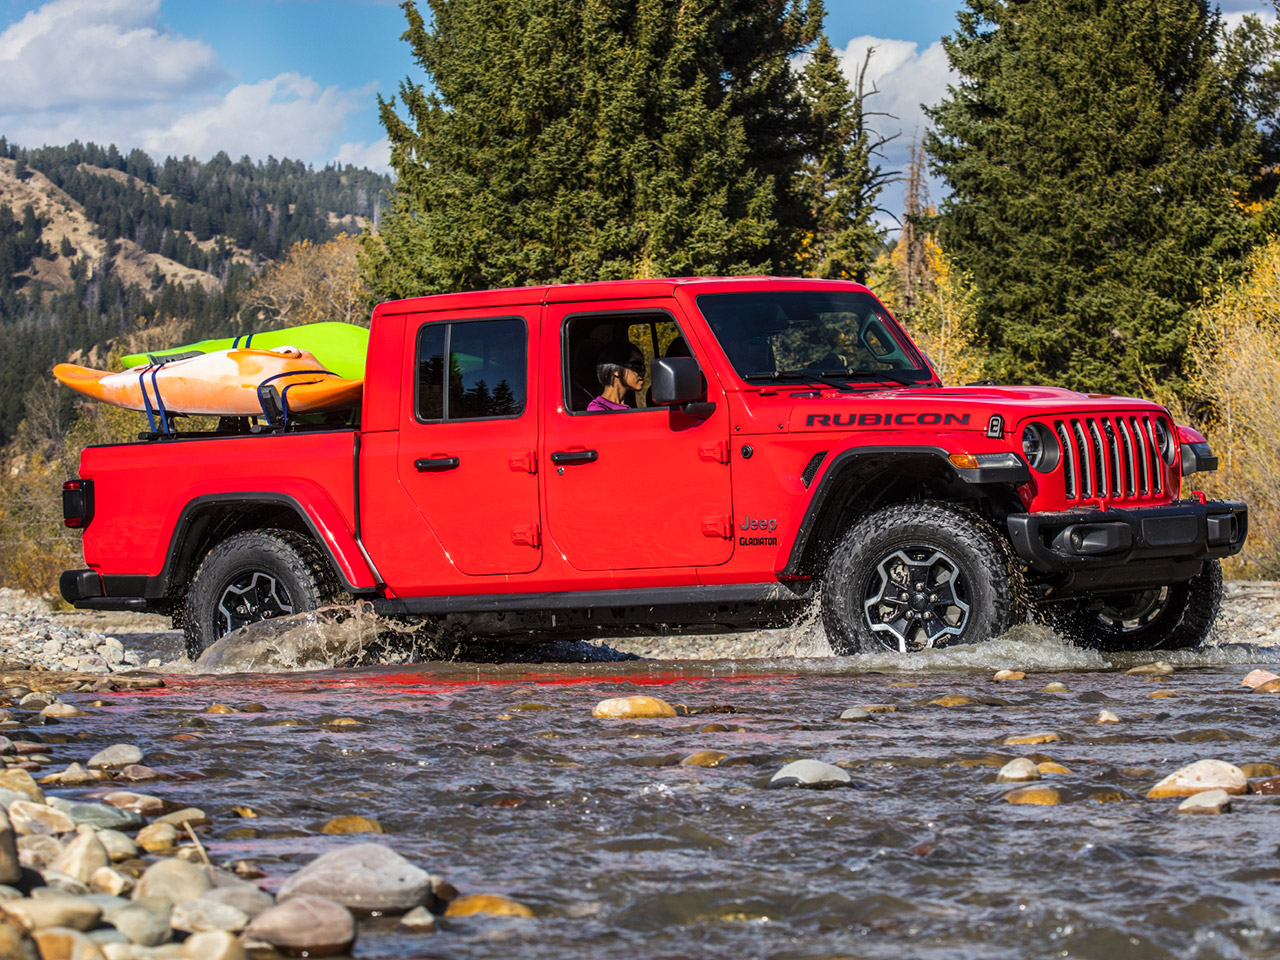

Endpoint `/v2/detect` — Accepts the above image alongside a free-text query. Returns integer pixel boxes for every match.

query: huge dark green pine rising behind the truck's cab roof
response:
[362,0,822,298]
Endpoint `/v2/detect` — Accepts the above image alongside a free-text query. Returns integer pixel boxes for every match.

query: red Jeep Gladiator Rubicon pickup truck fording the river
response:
[61,278,1248,657]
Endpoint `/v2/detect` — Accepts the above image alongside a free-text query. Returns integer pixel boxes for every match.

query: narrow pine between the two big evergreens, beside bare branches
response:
[800,35,896,283]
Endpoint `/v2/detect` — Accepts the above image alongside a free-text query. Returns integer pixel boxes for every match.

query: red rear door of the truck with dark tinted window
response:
[397,307,543,576]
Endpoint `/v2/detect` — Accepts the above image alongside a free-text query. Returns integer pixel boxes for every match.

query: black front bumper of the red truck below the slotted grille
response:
[1007,500,1249,573]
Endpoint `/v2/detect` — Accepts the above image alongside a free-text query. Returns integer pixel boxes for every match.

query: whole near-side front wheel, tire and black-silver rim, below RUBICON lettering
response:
[822,503,1024,654]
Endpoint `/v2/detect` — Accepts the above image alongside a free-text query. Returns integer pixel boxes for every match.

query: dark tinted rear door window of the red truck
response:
[415,319,529,421]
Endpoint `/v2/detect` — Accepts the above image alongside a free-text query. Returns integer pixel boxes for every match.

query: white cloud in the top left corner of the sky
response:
[0,0,223,111]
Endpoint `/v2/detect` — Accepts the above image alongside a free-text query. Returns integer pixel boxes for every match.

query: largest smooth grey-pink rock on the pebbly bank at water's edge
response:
[276,844,431,911]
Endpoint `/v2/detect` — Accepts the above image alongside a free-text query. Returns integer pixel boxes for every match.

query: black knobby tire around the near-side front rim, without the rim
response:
[822,502,1025,655]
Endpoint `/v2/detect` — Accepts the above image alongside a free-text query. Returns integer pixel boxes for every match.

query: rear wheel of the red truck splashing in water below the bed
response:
[183,529,339,660]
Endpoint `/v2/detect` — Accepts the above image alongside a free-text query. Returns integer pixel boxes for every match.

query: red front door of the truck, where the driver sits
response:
[540,300,733,571]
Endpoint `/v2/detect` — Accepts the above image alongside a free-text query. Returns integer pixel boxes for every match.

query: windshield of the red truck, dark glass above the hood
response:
[698,291,933,383]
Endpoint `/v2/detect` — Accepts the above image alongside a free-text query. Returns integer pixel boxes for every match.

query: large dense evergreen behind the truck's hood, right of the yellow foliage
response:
[928,0,1257,392]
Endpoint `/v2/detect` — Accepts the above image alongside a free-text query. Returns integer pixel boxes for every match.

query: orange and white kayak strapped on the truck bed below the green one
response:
[54,347,365,416]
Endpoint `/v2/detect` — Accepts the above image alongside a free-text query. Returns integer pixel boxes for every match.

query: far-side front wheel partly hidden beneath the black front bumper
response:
[1053,559,1222,652]
